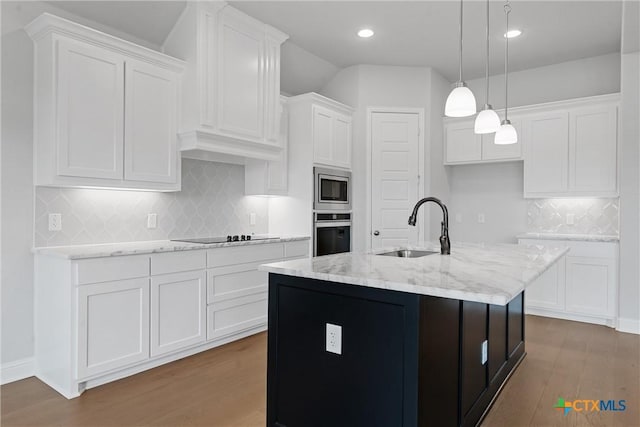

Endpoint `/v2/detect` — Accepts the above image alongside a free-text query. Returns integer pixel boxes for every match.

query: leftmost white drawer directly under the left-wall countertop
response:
[74,255,149,285]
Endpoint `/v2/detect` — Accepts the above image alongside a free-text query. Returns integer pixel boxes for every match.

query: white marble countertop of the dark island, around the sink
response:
[260,242,569,305]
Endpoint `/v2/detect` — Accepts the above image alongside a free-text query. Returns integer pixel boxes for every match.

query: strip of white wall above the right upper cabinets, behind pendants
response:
[467,53,620,109]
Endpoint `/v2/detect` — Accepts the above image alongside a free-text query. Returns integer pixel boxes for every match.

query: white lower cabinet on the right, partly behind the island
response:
[519,239,618,327]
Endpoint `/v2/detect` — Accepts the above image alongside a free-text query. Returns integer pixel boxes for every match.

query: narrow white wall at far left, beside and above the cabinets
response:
[0,1,168,365]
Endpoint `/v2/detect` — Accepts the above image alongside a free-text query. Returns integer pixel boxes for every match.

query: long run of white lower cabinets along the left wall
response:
[35,239,309,399]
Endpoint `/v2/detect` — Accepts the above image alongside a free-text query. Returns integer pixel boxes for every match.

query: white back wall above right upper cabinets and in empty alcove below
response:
[449,54,620,243]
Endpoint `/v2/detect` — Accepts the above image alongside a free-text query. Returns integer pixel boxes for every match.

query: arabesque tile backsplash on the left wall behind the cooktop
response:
[34,159,269,247]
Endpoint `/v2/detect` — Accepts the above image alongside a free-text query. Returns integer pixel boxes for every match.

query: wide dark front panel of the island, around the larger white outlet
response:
[276,286,405,427]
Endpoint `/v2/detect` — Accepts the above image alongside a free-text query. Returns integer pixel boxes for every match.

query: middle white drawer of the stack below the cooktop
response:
[207,263,269,304]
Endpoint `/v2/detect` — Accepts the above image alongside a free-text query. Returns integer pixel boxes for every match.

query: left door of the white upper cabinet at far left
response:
[56,39,124,180]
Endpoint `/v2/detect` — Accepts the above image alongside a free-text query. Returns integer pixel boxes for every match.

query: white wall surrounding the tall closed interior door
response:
[320,65,448,250]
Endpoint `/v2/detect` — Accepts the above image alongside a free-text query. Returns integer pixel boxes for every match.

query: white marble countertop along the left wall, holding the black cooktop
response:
[32,236,310,259]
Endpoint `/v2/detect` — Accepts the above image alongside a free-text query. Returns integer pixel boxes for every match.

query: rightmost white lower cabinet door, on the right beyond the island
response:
[566,256,616,318]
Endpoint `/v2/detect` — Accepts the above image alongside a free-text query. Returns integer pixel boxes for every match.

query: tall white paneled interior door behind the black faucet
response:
[370,112,423,249]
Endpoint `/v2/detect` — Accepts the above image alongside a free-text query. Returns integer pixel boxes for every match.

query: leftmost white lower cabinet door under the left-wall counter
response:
[77,278,149,379]
